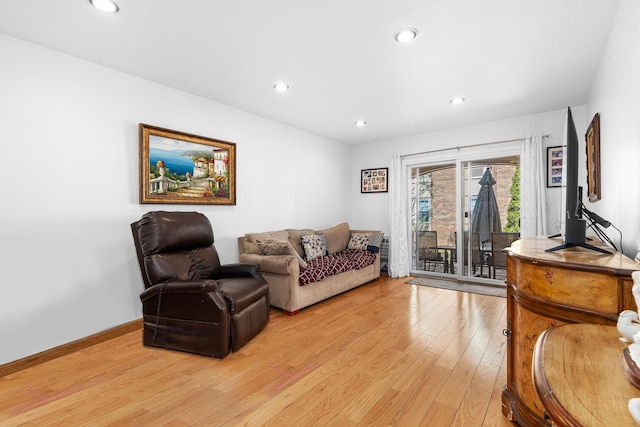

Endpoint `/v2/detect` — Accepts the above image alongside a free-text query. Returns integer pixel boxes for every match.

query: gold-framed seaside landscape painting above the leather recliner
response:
[138,123,236,205]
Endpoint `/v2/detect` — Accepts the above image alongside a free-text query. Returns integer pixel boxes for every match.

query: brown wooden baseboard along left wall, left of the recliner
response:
[0,319,142,377]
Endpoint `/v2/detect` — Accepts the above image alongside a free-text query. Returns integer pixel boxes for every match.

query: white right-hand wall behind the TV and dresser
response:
[588,0,640,258]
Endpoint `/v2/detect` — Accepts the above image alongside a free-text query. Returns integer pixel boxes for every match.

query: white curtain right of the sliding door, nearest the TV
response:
[520,135,547,237]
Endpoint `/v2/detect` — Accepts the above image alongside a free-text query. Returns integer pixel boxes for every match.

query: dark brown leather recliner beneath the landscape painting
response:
[131,211,269,358]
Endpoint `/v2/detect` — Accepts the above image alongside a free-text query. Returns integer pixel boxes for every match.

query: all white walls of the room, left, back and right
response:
[5,0,640,364]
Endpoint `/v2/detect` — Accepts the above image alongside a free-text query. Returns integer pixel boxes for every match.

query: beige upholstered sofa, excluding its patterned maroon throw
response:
[238,223,380,315]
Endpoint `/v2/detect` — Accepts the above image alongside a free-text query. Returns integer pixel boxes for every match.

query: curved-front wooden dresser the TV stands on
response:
[502,237,640,426]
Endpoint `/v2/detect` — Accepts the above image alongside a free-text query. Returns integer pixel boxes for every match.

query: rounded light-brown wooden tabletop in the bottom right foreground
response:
[533,324,640,427]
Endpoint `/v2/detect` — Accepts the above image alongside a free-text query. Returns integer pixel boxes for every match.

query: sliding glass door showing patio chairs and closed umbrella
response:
[409,154,520,283]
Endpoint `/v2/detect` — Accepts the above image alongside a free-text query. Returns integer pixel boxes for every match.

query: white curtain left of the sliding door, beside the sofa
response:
[389,154,411,277]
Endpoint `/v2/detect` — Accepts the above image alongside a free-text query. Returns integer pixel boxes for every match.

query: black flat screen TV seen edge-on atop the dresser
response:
[546,107,611,254]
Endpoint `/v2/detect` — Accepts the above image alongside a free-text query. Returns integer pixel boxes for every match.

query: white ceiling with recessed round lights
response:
[0,0,619,145]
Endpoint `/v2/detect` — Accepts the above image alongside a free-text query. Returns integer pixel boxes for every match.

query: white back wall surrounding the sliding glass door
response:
[352,105,587,239]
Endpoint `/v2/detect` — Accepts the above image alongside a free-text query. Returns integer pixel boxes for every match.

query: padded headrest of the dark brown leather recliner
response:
[138,211,213,256]
